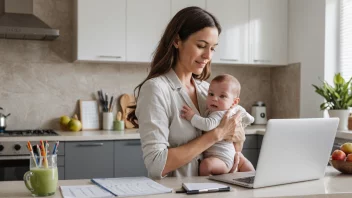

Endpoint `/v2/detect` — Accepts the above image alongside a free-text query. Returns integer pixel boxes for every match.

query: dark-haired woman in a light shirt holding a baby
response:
[129,7,254,178]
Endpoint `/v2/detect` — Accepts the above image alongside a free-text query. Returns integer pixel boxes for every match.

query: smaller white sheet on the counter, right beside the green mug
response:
[60,185,115,198]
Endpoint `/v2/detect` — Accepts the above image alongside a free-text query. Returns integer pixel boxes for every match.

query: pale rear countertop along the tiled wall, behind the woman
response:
[0,125,352,142]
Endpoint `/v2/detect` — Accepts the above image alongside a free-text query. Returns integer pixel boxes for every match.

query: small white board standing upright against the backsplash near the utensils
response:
[79,100,100,130]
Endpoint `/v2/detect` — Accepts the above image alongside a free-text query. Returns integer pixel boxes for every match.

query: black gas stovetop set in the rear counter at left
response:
[0,129,59,137]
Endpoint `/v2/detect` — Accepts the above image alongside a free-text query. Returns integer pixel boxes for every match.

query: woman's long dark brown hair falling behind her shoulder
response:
[127,6,221,127]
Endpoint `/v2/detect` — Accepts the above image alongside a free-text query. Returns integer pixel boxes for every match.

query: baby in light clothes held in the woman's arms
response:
[181,74,254,176]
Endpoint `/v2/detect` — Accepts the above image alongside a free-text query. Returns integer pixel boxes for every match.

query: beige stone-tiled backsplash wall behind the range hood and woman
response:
[0,0,300,129]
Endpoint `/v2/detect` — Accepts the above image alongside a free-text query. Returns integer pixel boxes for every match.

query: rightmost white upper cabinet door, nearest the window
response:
[249,0,288,65]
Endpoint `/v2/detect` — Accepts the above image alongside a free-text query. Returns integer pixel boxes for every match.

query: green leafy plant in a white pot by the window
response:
[313,73,352,130]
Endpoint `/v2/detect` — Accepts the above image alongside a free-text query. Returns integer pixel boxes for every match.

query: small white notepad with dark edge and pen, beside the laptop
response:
[182,183,231,194]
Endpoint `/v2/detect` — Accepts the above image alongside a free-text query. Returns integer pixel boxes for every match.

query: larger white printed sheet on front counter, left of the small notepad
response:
[92,177,172,197]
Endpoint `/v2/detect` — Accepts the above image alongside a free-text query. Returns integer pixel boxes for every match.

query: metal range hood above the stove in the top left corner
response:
[0,0,59,40]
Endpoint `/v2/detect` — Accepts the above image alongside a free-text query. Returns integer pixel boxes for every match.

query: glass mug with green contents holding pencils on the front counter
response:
[23,155,58,197]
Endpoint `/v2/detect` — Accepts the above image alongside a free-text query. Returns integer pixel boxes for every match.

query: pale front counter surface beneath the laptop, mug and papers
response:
[0,167,352,198]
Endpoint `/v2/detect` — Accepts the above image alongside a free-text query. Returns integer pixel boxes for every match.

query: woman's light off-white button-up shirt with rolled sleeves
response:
[136,69,209,178]
